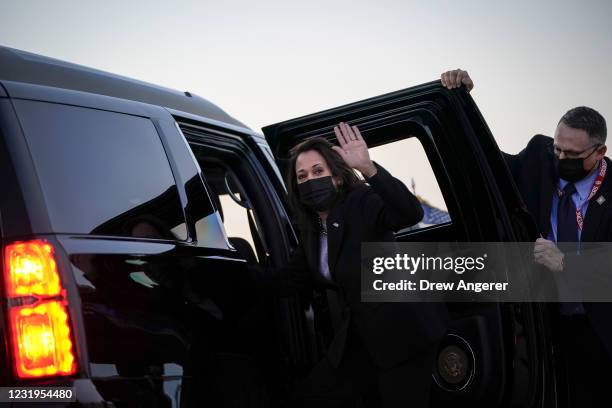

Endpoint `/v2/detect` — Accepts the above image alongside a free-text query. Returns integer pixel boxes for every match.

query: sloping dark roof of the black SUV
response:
[0,46,248,129]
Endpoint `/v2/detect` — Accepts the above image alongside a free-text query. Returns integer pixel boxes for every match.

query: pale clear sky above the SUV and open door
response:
[0,0,612,214]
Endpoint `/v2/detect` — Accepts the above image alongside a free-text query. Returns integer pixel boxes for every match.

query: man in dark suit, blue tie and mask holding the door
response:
[442,70,612,407]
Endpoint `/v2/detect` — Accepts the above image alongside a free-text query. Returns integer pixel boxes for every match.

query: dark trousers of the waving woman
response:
[291,323,437,408]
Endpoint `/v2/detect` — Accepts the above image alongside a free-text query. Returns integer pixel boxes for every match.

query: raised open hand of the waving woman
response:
[333,122,376,178]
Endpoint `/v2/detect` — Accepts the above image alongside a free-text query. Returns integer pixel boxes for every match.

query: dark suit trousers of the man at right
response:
[561,315,612,407]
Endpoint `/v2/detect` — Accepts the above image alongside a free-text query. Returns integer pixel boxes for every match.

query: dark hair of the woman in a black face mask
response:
[286,137,363,228]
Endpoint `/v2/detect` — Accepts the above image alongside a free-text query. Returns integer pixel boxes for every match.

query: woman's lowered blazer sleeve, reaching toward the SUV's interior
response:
[247,245,312,296]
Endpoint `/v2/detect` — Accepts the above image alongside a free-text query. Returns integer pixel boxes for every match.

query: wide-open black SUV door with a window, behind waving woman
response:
[263,81,554,407]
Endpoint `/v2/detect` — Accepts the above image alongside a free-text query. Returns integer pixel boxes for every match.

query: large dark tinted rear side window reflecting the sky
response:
[16,101,187,239]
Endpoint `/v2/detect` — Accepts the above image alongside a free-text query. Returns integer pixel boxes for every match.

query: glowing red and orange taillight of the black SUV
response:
[4,240,76,378]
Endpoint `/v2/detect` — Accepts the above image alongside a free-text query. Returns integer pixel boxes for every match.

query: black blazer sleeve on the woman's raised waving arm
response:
[361,163,423,231]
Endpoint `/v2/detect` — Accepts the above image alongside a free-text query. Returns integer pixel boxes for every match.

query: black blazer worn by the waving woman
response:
[251,164,448,367]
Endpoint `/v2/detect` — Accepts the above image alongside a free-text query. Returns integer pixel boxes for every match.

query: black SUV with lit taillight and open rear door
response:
[0,47,562,407]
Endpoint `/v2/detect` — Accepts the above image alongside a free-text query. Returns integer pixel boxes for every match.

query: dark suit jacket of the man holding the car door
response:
[504,135,612,355]
